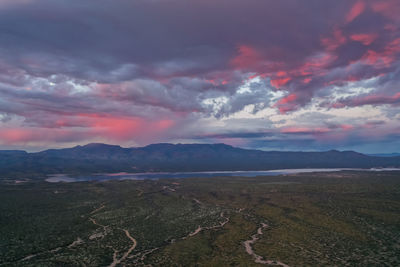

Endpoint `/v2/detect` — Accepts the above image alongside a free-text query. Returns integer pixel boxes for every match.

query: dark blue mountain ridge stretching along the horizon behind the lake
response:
[0,143,400,177]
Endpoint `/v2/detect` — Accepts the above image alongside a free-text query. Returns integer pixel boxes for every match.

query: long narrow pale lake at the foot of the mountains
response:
[46,168,400,183]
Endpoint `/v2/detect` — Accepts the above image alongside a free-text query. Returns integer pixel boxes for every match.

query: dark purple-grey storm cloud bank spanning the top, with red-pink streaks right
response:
[0,0,397,104]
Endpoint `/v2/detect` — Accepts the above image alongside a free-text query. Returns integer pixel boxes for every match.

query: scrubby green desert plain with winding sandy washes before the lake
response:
[0,171,400,266]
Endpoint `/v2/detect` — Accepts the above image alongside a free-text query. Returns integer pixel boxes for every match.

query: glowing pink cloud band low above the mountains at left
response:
[0,113,175,144]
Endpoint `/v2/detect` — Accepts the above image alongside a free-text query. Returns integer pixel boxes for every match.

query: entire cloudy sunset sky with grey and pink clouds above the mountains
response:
[0,0,400,153]
